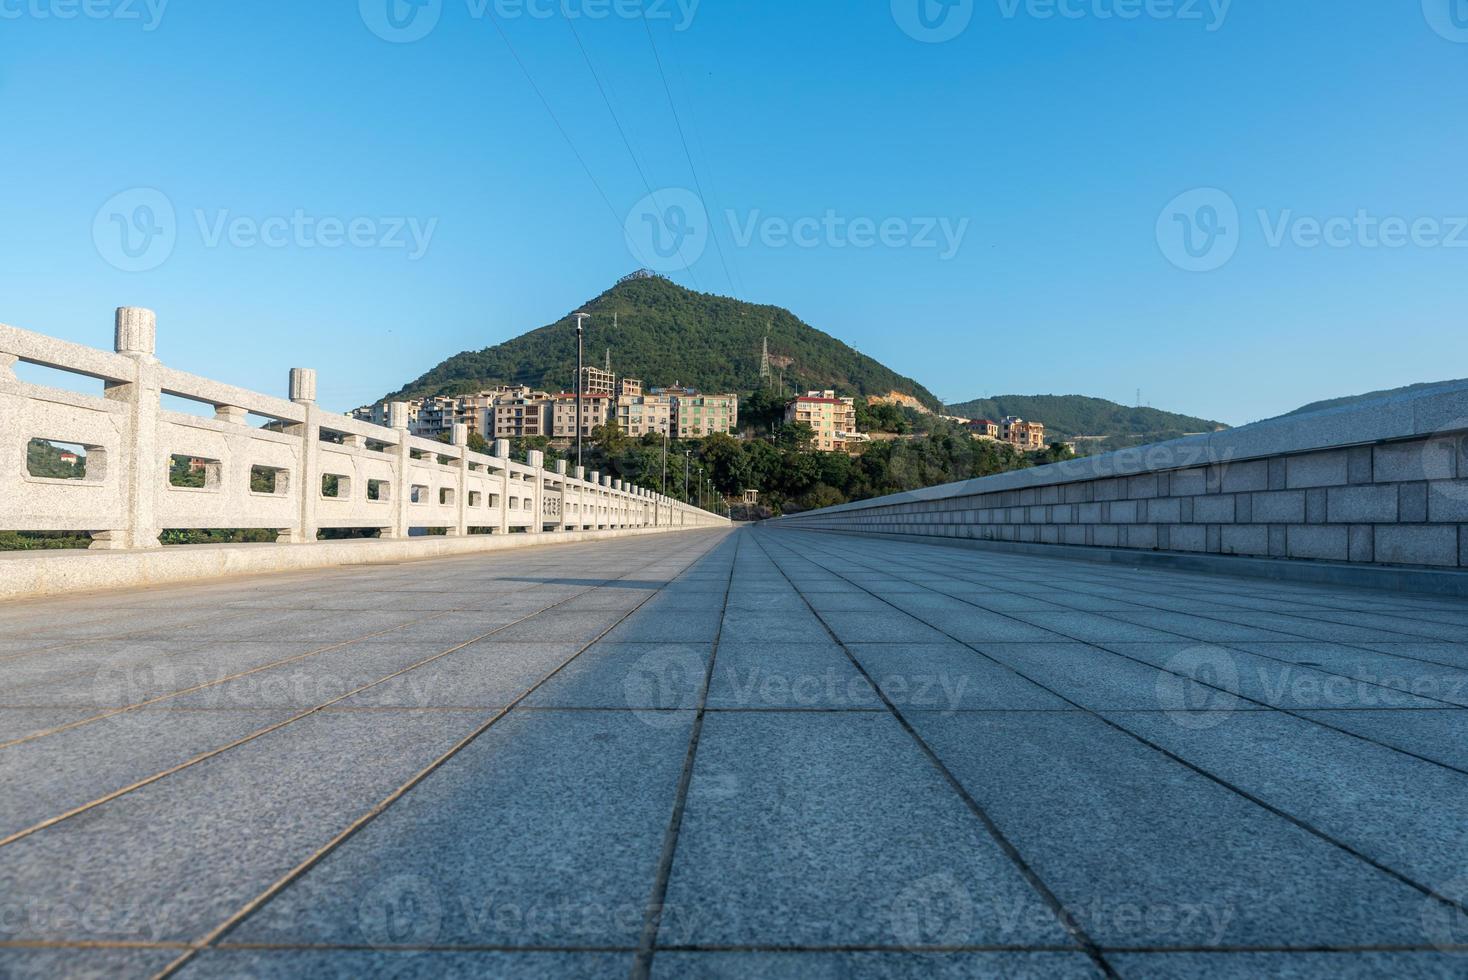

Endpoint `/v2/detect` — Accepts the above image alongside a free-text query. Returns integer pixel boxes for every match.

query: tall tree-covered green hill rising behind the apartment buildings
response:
[389,276,938,408]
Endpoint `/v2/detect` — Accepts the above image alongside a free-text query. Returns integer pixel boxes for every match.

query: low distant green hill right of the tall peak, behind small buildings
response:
[947,395,1226,449]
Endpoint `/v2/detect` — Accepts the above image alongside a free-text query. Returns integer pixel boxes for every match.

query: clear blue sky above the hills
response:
[0,0,1468,424]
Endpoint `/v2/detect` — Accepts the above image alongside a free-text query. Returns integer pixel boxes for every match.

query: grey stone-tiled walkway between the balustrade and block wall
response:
[0,528,1468,979]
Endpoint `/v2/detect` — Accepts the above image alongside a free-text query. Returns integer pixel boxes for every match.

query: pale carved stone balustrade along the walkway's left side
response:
[0,308,728,549]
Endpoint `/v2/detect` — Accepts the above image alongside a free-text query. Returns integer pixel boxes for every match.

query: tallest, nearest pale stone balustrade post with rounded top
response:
[91,307,167,550]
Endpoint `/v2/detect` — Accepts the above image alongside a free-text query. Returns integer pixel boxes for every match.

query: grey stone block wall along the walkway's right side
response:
[781,384,1468,569]
